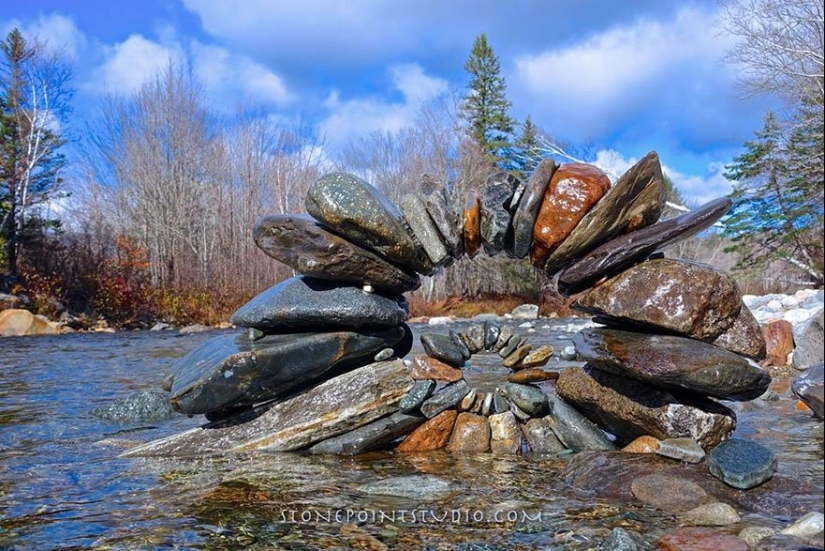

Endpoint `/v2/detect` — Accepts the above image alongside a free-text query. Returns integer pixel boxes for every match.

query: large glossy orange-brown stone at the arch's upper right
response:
[530,163,610,267]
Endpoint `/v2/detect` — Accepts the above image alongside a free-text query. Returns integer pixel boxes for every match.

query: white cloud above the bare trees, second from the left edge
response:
[90,34,185,94]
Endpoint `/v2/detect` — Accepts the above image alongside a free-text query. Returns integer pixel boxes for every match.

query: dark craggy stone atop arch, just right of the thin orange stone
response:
[480,171,521,256]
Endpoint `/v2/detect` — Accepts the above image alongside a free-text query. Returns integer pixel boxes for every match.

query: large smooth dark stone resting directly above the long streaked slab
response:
[170,327,404,414]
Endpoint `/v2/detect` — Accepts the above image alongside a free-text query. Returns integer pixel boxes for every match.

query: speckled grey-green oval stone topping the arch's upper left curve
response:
[306,172,432,273]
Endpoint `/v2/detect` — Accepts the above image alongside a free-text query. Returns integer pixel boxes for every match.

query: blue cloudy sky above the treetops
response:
[0,0,770,203]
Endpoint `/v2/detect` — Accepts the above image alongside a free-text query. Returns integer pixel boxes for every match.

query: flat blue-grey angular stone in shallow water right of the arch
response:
[708,438,776,490]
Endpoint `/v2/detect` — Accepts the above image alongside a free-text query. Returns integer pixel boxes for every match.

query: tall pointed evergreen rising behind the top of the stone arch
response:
[462,33,515,167]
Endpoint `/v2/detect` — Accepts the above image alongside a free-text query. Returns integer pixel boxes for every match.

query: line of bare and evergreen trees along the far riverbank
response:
[0,0,823,326]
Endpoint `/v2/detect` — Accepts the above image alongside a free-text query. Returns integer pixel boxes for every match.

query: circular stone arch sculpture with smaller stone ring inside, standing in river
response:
[127,152,770,484]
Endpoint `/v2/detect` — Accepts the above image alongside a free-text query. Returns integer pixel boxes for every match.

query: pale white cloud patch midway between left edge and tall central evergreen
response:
[191,42,291,107]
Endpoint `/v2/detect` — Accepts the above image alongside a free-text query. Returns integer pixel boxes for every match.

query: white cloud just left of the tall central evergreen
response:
[321,65,448,149]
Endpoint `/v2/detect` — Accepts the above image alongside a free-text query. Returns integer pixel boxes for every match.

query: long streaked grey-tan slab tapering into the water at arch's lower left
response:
[123,360,413,457]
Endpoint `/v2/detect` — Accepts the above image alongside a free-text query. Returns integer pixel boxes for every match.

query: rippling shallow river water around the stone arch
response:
[0,326,823,551]
